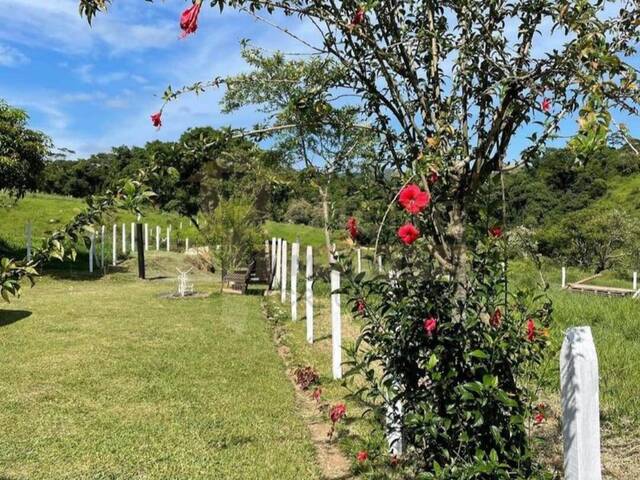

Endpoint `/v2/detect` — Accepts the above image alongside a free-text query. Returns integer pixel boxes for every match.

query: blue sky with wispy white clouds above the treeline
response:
[0,0,640,158]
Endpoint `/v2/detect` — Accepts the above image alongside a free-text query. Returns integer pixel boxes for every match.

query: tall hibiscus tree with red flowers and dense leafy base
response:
[80,0,640,479]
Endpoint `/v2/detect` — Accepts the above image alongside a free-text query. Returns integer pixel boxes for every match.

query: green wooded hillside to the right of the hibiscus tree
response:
[506,142,640,270]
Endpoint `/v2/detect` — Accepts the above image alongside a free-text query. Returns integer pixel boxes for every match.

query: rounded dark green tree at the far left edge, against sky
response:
[0,99,52,198]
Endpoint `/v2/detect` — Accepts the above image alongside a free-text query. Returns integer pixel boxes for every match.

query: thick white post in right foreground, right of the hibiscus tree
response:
[560,327,602,480]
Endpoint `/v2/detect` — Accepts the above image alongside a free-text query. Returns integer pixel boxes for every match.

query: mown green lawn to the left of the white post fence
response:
[0,254,317,480]
